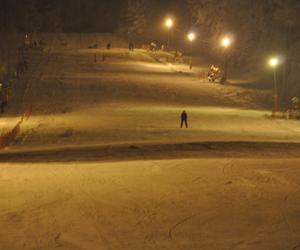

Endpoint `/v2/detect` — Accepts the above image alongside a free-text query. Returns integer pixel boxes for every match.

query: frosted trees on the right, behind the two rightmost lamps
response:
[188,0,300,101]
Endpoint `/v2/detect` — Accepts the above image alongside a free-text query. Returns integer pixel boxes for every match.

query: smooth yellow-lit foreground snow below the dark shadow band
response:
[0,158,300,250]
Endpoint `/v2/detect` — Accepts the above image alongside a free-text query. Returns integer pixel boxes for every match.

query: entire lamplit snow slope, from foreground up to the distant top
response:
[0,49,300,250]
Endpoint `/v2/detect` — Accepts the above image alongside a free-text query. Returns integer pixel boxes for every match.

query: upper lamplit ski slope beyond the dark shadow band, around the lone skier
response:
[0,49,300,154]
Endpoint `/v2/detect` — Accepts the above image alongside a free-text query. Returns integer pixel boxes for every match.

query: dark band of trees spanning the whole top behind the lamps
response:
[0,0,300,65]
